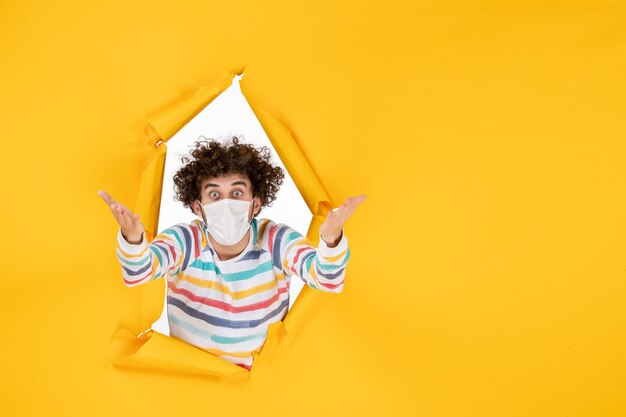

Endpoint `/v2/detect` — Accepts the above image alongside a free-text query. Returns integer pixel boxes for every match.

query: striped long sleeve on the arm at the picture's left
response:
[116,223,203,287]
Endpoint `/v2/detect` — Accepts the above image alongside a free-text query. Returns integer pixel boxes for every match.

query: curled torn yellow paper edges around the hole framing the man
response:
[110,71,333,378]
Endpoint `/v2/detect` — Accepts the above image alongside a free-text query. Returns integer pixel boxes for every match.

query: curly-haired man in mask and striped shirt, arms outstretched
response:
[98,138,365,370]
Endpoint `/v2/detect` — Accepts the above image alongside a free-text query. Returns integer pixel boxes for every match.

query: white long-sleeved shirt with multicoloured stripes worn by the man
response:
[116,217,350,370]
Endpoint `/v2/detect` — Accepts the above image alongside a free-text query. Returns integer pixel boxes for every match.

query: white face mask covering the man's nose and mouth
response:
[196,198,254,245]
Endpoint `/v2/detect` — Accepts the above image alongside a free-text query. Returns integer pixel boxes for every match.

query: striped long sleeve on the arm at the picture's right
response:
[272,224,350,293]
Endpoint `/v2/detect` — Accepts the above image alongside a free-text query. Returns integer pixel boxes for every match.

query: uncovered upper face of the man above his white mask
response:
[193,174,260,220]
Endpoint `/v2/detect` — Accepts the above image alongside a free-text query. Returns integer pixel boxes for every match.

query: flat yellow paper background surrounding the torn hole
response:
[0,1,626,416]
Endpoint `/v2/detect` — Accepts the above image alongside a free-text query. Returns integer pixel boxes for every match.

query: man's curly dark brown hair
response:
[174,136,285,217]
